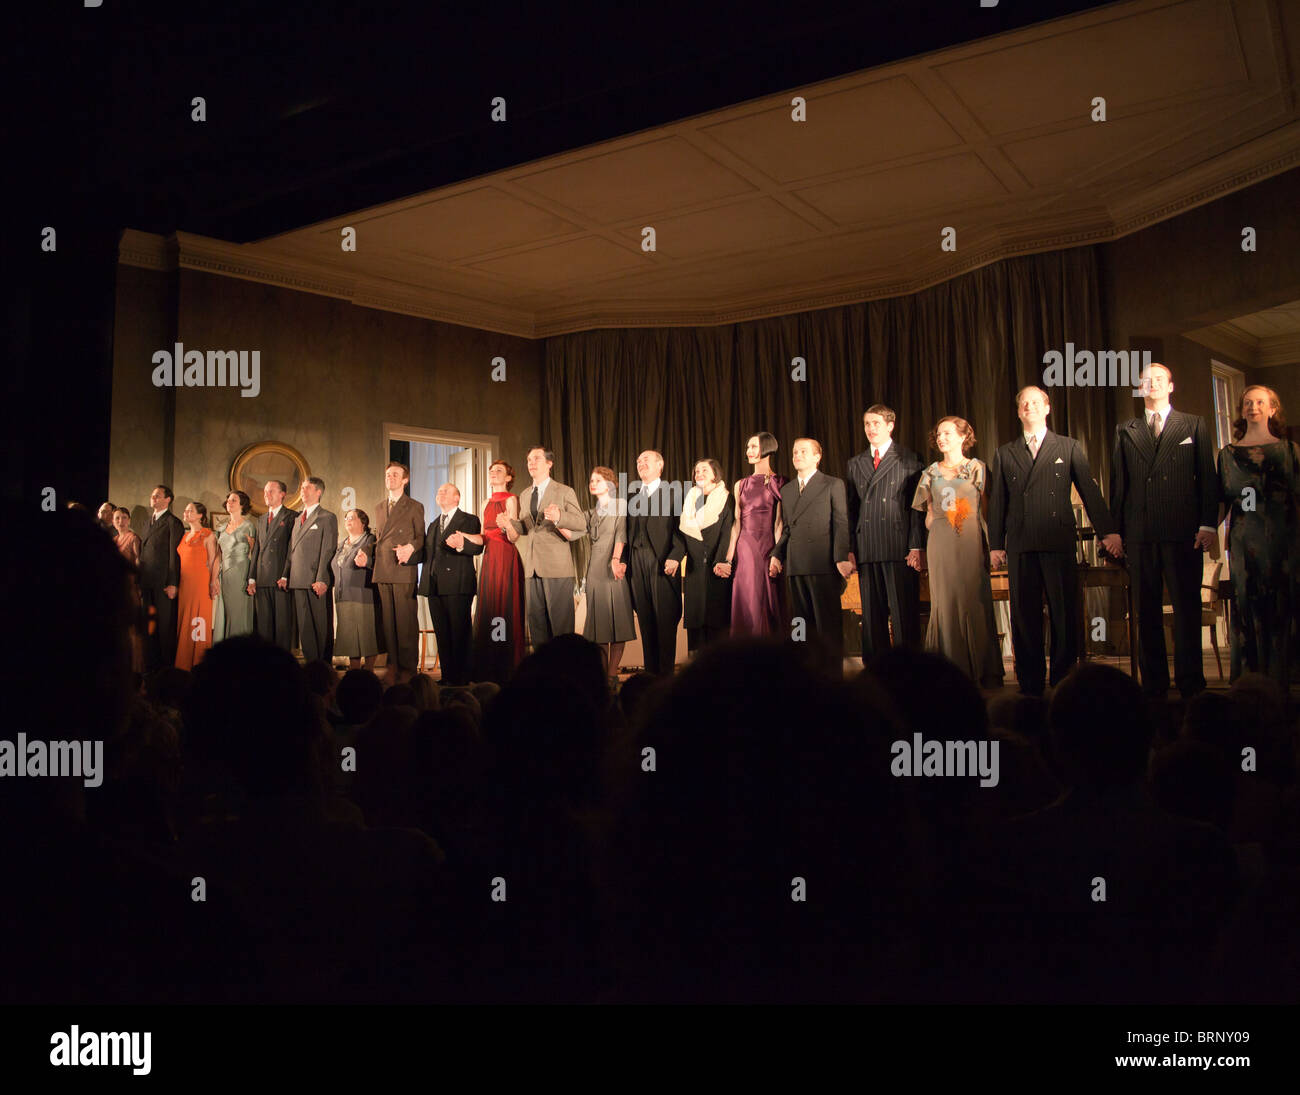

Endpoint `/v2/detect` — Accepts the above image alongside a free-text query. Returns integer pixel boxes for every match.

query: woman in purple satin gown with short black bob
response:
[714,432,787,635]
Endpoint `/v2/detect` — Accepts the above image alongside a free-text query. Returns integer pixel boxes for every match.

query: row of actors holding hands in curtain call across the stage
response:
[124,364,1300,696]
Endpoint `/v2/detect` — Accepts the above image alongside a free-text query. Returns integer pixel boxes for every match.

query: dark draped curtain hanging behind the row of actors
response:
[538,247,1118,507]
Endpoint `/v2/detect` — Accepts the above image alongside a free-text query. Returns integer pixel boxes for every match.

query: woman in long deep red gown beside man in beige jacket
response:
[464,460,527,684]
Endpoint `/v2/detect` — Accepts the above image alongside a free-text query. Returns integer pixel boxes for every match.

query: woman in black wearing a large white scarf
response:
[680,458,736,653]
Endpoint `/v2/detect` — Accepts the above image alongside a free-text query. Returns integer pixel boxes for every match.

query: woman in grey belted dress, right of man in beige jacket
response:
[564,467,637,680]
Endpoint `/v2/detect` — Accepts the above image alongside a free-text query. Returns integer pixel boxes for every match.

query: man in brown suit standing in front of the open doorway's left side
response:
[374,460,424,683]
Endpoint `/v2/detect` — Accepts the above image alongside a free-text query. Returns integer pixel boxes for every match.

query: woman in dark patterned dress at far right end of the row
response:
[1218,388,1300,688]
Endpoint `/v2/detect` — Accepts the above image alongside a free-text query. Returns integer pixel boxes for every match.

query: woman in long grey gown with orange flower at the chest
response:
[911,415,1002,688]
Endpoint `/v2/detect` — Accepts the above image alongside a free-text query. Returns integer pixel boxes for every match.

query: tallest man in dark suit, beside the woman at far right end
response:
[1110,364,1219,697]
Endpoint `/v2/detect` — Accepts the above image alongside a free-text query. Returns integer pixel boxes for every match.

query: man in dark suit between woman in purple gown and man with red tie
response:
[768,437,853,667]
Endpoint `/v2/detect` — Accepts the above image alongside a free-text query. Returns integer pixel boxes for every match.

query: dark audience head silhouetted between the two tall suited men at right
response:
[1048,662,1152,789]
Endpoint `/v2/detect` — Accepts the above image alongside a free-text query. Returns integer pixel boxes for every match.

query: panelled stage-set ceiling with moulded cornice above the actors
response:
[120,0,1300,338]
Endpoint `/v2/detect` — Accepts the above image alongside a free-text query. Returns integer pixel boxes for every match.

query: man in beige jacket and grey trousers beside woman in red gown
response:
[497,446,586,650]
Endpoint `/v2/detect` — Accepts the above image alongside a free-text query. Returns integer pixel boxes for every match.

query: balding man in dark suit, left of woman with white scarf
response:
[624,449,686,674]
